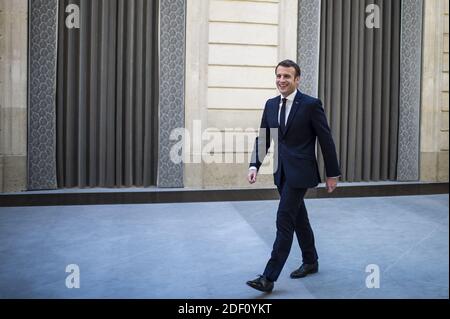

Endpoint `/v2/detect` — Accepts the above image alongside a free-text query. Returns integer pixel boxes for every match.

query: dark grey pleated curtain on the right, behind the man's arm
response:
[319,0,401,181]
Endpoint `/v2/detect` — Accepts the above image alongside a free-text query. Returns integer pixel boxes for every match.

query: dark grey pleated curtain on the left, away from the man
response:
[57,0,159,187]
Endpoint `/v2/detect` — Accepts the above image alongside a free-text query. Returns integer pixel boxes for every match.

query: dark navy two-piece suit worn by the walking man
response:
[250,91,341,281]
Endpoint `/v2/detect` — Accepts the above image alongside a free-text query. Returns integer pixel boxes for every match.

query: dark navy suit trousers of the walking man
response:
[263,167,318,281]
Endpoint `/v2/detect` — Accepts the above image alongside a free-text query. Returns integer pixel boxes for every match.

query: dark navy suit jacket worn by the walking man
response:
[250,91,341,188]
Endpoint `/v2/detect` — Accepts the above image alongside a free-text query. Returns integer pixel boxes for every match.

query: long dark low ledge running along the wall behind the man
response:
[0,182,449,207]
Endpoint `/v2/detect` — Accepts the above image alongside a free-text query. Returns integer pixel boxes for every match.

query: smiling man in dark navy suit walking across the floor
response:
[247,60,341,292]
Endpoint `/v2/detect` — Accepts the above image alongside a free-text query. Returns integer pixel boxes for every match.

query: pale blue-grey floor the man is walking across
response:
[0,195,449,299]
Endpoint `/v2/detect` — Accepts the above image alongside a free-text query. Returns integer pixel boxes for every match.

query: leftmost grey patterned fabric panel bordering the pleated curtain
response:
[28,0,58,189]
